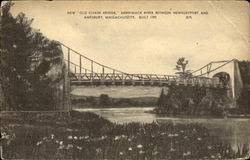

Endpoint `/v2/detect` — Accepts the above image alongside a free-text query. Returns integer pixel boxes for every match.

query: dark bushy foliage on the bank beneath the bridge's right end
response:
[155,86,232,117]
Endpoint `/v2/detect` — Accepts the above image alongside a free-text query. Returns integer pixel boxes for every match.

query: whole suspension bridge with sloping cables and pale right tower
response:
[60,43,241,100]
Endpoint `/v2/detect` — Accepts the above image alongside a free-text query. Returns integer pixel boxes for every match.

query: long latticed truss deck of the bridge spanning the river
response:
[71,73,227,88]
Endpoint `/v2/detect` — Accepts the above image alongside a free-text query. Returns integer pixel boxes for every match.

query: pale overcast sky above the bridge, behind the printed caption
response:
[8,1,250,74]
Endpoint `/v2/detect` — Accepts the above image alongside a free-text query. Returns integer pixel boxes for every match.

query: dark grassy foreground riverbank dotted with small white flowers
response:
[0,111,248,159]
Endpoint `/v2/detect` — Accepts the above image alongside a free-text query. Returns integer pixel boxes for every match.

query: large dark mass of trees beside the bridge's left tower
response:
[0,2,62,110]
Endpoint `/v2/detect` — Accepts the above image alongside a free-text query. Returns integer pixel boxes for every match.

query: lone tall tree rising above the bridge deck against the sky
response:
[175,57,192,78]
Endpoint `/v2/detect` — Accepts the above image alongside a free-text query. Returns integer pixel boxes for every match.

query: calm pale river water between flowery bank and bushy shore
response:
[75,107,250,151]
